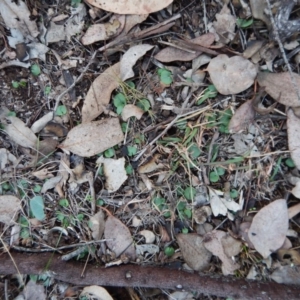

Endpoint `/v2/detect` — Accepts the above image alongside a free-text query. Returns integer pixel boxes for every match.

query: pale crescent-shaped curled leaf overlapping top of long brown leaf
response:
[120,44,154,81]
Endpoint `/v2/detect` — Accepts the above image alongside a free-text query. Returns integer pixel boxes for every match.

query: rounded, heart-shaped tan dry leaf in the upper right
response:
[207,54,257,95]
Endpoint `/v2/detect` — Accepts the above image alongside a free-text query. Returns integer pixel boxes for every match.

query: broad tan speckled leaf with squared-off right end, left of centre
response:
[59,118,124,157]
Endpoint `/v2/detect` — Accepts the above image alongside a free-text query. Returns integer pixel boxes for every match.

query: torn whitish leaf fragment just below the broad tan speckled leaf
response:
[97,156,128,193]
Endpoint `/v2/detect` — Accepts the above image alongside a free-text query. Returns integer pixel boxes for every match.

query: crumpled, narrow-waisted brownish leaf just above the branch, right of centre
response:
[203,230,240,275]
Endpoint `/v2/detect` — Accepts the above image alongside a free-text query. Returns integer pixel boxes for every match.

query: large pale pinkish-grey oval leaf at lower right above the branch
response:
[248,199,289,258]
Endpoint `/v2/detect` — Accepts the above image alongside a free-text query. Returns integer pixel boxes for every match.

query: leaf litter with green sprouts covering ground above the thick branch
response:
[0,0,300,299]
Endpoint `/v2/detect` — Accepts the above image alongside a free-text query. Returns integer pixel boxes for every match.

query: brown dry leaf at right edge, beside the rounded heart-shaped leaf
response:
[257,72,300,107]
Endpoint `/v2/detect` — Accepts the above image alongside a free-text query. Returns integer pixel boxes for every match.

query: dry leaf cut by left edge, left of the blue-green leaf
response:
[0,195,21,225]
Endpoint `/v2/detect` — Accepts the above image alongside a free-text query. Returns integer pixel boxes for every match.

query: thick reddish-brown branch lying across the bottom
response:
[0,252,300,300]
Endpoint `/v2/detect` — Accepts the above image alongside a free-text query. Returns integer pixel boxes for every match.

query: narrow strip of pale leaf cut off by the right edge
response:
[287,109,300,169]
